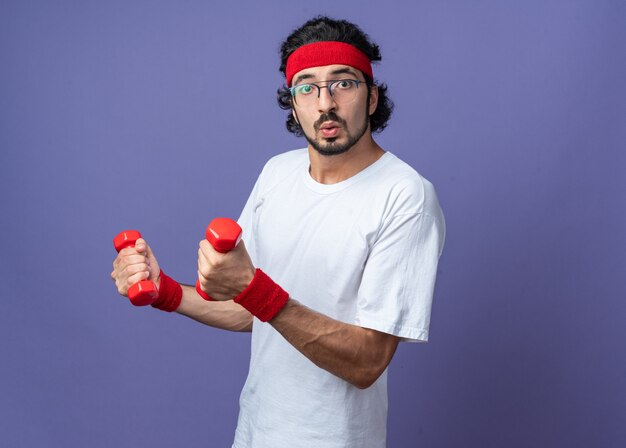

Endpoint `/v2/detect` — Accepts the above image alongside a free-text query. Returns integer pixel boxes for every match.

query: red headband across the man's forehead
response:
[285,42,374,87]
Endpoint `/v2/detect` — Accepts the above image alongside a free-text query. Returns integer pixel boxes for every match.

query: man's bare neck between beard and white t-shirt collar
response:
[309,134,385,184]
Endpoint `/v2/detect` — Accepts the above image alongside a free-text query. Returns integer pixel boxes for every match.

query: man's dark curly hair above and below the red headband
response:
[278,16,393,136]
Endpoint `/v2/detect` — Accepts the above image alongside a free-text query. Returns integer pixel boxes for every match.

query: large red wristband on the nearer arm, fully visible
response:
[233,269,289,322]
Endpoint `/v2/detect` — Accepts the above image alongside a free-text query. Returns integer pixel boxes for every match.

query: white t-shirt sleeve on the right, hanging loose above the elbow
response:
[355,212,445,342]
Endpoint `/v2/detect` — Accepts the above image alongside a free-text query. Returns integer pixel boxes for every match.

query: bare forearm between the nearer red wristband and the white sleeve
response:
[269,299,399,389]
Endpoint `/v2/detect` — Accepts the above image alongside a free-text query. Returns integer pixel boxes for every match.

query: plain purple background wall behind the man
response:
[0,0,626,448]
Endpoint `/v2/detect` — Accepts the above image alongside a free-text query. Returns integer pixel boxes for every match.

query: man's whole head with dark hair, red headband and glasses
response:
[278,17,393,155]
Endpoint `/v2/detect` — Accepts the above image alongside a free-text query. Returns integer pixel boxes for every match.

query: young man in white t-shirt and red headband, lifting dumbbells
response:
[112,17,445,448]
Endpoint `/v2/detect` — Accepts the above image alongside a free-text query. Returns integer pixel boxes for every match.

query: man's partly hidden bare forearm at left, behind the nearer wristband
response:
[176,285,252,331]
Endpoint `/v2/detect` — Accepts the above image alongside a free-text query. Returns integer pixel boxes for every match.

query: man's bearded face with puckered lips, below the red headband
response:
[292,65,378,156]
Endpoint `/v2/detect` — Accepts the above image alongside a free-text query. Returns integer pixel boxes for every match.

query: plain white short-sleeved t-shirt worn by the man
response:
[233,149,445,448]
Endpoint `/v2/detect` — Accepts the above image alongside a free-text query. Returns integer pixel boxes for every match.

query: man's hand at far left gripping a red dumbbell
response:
[111,238,161,297]
